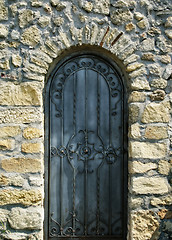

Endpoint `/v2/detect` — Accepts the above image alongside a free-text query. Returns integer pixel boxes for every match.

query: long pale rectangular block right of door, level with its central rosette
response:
[129,142,167,159]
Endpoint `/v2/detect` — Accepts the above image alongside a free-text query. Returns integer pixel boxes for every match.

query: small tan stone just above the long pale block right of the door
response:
[145,125,168,139]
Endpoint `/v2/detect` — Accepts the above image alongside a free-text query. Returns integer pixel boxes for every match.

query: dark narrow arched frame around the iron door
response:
[43,46,128,240]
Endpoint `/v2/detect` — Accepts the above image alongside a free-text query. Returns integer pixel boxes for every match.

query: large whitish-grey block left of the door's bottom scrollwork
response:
[8,207,42,229]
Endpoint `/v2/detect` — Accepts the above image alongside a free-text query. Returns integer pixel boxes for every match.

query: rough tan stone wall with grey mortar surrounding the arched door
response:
[0,0,172,240]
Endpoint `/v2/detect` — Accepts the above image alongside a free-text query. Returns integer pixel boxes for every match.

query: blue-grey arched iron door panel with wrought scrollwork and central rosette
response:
[48,55,124,239]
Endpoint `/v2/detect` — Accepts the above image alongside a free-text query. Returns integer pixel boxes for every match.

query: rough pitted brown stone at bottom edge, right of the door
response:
[131,210,159,240]
